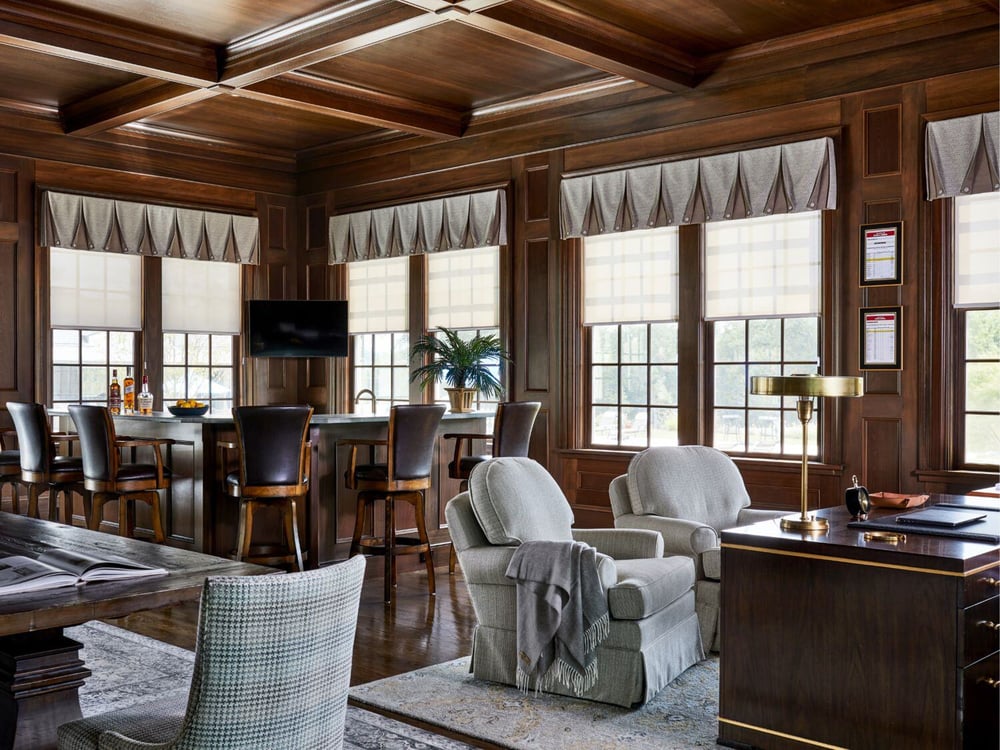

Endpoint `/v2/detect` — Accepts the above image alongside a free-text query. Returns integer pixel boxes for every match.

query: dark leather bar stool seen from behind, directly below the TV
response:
[226,406,313,570]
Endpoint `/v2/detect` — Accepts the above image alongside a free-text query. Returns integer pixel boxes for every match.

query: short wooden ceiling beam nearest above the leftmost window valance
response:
[62,78,227,136]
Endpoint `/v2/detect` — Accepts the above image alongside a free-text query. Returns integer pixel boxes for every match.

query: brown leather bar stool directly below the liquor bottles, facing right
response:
[69,404,173,544]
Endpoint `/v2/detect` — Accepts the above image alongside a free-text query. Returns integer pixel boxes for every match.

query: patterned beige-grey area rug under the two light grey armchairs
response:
[350,658,719,750]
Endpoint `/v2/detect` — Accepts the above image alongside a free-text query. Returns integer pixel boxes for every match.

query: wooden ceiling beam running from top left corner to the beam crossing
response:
[0,0,218,86]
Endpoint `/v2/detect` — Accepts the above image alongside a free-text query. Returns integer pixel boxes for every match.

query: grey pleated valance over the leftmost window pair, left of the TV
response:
[41,191,260,263]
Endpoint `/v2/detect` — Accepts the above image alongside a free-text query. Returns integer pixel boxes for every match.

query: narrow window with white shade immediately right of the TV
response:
[347,257,410,414]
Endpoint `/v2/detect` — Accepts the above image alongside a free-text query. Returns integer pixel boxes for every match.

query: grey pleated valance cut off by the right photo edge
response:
[925,112,1000,200]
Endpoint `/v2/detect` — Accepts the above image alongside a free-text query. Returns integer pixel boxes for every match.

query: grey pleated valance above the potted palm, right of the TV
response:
[330,190,507,264]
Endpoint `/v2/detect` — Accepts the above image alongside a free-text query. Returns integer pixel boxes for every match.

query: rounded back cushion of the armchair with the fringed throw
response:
[469,458,573,544]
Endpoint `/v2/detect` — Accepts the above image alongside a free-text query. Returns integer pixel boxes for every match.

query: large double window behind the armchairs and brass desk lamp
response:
[582,212,822,456]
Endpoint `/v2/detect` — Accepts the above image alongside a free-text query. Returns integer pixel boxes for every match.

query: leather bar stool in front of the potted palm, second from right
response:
[348,404,444,603]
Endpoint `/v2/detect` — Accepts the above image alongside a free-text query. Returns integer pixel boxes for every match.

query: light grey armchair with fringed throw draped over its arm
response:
[445,458,704,706]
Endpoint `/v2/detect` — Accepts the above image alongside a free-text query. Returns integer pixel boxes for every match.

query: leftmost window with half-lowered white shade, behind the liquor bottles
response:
[49,247,142,406]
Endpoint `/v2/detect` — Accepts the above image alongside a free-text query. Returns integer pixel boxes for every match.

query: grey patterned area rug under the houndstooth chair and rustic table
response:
[65,620,470,750]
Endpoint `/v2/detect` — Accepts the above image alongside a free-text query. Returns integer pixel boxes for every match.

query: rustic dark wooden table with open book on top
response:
[0,513,275,750]
